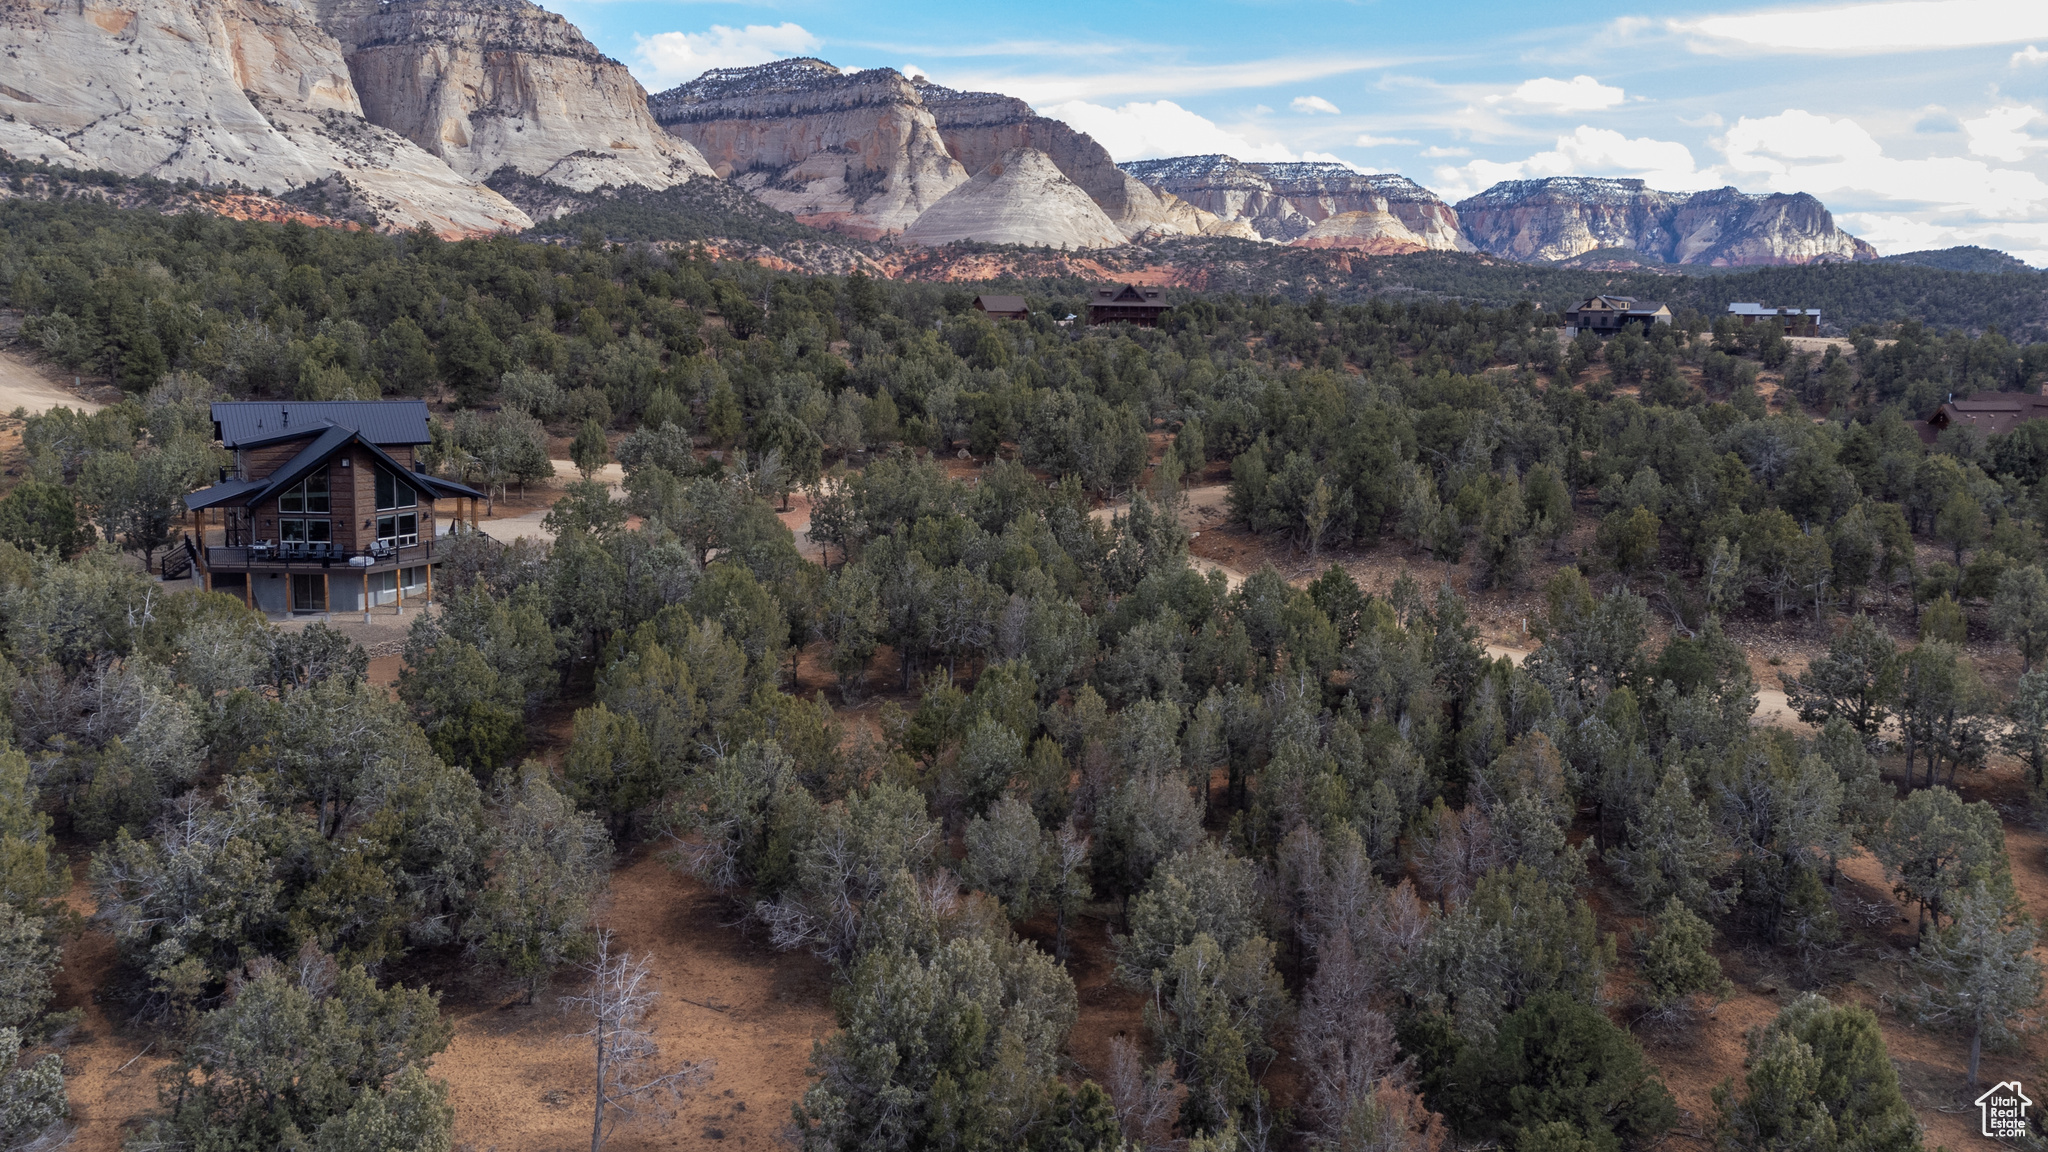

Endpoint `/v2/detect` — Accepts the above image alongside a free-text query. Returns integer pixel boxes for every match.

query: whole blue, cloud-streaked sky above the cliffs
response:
[545,0,2048,266]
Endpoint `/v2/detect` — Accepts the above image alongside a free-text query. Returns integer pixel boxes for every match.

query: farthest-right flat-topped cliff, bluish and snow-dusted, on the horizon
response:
[1458,176,1876,264]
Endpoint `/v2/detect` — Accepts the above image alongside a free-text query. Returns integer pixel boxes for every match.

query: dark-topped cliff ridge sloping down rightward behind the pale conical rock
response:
[915,82,1257,240]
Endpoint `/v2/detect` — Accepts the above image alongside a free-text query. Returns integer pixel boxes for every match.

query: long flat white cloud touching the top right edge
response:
[1671,0,2048,55]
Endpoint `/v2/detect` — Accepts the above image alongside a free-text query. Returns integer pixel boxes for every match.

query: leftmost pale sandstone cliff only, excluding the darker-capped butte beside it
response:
[0,0,530,232]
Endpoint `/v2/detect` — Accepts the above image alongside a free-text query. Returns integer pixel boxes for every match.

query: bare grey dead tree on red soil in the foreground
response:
[561,931,711,1152]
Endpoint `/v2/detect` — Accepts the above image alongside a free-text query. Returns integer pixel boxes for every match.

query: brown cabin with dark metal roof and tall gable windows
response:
[166,400,483,615]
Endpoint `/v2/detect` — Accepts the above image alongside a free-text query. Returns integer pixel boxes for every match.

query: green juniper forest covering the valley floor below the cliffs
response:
[0,192,2048,1152]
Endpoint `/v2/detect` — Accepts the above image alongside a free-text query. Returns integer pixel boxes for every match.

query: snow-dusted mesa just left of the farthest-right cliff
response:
[1122,156,1473,252]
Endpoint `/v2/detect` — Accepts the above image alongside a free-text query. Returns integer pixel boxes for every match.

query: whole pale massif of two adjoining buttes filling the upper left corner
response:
[0,0,711,234]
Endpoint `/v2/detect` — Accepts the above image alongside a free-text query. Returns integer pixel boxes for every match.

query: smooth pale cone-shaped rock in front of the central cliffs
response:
[903,148,1124,248]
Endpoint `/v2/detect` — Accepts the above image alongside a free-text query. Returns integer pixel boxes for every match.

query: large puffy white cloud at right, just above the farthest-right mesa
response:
[1722,109,2048,219]
